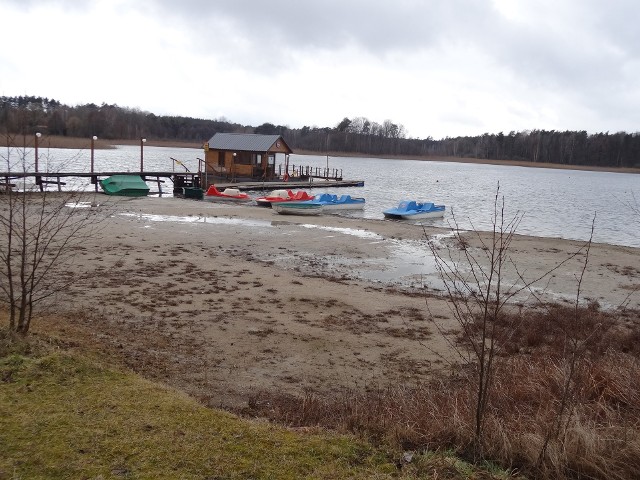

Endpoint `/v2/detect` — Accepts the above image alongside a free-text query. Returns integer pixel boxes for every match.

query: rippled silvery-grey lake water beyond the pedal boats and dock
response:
[6,146,640,247]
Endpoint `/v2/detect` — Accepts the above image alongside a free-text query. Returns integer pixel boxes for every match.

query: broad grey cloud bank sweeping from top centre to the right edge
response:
[145,0,640,132]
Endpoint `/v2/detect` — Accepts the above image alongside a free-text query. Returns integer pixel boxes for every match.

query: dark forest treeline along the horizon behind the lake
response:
[0,96,640,167]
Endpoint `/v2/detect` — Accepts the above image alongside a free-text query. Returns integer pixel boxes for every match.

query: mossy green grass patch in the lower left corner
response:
[0,353,398,479]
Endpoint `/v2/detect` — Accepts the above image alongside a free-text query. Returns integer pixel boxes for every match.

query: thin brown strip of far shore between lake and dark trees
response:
[0,134,640,173]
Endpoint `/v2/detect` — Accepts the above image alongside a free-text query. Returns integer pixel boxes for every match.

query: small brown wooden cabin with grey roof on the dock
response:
[203,133,292,181]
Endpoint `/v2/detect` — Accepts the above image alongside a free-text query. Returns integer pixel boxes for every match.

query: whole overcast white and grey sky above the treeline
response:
[0,0,640,139]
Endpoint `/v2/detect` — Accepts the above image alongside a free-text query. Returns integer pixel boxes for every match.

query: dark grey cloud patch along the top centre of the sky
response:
[150,0,491,53]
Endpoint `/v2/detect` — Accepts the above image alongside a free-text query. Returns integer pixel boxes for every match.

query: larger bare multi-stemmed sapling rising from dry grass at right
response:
[427,185,580,459]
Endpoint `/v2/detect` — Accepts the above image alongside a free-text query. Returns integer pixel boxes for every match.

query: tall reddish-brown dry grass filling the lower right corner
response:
[241,305,640,479]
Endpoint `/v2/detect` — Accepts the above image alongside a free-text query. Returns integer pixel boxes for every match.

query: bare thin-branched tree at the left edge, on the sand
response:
[0,139,105,335]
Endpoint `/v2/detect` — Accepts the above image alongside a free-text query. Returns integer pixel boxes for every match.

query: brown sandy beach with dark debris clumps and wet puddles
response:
[43,195,640,409]
